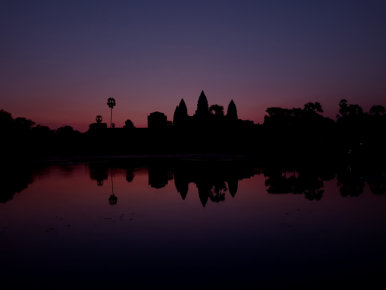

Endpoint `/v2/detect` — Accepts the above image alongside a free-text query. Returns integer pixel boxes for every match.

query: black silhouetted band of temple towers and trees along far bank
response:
[0,92,386,162]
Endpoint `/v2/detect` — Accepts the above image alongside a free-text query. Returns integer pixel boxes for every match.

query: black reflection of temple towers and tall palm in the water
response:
[89,162,256,206]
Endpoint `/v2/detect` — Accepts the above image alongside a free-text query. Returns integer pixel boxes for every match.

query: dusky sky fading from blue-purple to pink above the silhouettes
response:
[0,0,386,131]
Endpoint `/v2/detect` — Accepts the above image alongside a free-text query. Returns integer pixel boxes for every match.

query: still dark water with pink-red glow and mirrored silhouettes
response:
[0,163,386,289]
